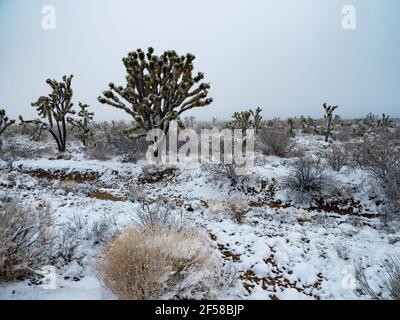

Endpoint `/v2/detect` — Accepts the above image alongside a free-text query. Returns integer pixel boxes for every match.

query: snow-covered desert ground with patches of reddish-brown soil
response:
[0,136,400,299]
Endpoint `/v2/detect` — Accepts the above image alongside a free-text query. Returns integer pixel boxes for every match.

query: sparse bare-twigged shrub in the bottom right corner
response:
[356,257,400,300]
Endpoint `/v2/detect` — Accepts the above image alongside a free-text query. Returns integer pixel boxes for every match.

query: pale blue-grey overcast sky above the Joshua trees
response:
[0,0,400,120]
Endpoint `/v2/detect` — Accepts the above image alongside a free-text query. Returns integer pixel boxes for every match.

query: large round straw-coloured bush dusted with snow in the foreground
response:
[99,228,220,300]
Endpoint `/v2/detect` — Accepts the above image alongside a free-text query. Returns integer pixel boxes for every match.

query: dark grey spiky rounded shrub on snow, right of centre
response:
[285,157,332,197]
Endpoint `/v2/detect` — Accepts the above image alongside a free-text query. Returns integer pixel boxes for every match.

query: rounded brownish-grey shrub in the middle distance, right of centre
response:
[258,127,290,157]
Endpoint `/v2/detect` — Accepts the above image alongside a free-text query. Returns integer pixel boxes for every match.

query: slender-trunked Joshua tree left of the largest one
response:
[27,75,75,152]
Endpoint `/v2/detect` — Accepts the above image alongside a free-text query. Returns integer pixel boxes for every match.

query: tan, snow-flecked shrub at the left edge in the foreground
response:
[0,201,52,281]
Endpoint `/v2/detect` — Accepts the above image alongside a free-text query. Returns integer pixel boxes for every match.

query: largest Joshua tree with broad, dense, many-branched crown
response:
[99,48,212,138]
